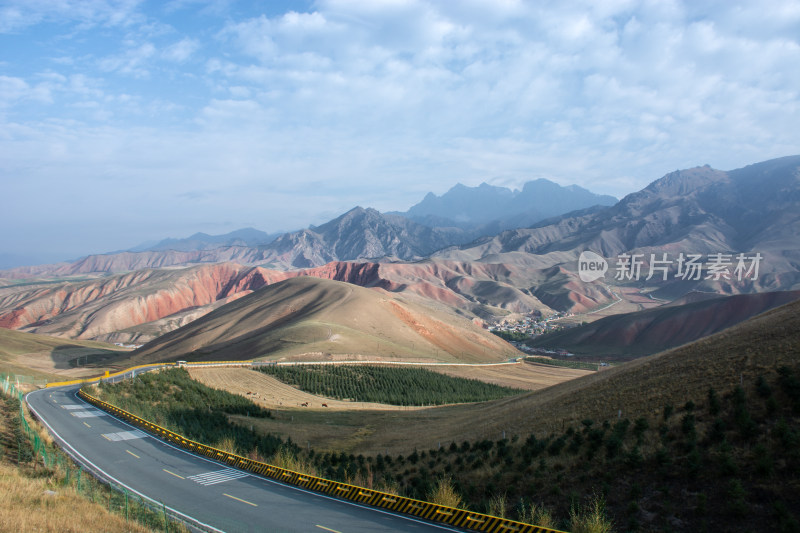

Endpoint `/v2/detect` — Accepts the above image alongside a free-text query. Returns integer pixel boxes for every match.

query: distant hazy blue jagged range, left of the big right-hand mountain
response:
[0,179,616,279]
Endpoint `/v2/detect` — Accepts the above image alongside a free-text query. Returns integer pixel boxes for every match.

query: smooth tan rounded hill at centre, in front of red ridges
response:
[126,276,518,362]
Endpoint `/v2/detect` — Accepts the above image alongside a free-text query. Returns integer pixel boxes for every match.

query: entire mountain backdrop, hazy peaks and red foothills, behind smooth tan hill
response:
[0,156,800,362]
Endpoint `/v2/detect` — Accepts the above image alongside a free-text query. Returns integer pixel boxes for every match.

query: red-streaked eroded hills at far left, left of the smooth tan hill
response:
[0,263,287,342]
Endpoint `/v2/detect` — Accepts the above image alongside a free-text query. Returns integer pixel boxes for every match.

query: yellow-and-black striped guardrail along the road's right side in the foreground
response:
[78,386,564,533]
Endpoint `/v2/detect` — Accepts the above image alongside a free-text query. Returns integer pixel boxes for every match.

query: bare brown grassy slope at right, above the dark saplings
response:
[265,301,800,453]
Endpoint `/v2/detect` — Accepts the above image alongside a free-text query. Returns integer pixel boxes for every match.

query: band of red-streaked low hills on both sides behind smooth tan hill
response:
[0,261,576,343]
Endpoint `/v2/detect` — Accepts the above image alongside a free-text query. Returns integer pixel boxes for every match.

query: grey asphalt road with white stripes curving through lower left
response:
[26,386,460,533]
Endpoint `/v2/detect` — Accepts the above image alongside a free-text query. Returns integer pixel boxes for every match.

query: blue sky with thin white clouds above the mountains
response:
[0,0,800,267]
